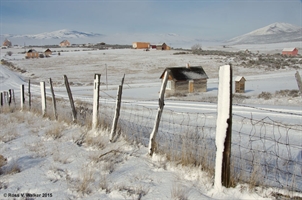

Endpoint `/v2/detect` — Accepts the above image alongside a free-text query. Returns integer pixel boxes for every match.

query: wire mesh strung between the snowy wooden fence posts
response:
[0,88,302,192]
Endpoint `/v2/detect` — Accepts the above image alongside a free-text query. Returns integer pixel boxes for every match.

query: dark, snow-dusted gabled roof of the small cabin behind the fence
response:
[160,66,209,81]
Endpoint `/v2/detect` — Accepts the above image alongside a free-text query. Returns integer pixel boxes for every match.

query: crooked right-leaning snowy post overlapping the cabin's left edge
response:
[149,70,170,156]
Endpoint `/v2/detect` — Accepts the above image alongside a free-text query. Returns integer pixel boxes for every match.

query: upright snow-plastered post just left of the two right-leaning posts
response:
[92,74,101,129]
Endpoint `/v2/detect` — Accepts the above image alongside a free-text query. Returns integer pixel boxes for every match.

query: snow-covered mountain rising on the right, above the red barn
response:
[226,23,302,44]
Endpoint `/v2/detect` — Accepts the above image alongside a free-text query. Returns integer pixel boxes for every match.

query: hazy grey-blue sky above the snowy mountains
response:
[0,0,302,40]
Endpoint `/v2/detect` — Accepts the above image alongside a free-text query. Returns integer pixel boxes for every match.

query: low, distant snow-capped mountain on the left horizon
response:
[0,29,102,39]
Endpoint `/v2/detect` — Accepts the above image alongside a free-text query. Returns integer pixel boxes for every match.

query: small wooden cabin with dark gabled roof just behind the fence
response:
[160,64,208,96]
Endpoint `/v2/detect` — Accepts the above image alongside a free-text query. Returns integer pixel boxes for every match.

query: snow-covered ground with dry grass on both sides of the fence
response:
[0,47,302,199]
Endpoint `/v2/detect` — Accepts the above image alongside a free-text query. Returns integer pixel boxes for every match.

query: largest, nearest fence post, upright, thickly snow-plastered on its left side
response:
[214,65,232,189]
